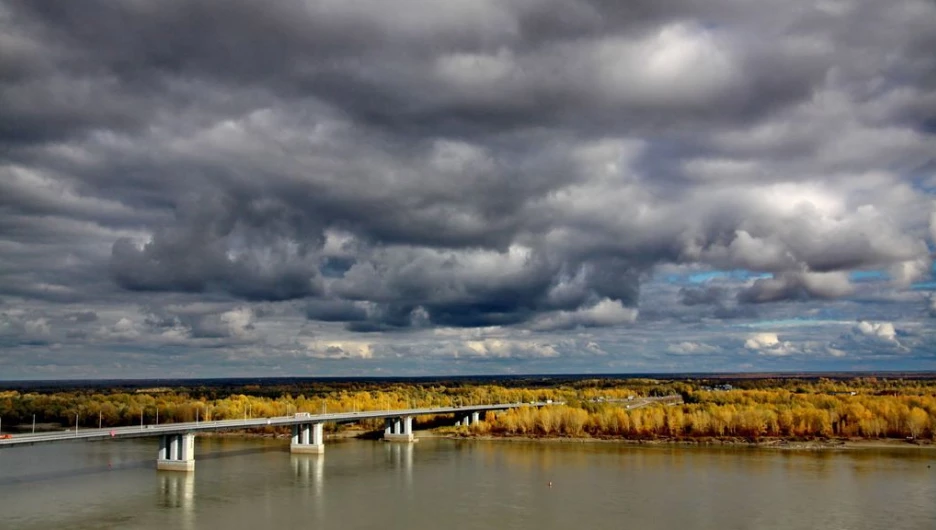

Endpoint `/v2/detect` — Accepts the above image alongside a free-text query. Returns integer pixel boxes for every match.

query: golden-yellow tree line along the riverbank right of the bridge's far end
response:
[471,391,936,439]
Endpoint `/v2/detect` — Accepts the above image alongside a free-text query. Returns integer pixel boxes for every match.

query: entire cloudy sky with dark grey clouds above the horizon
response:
[0,0,936,380]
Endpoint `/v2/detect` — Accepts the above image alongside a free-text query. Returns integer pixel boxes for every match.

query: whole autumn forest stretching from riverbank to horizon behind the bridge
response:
[0,377,936,440]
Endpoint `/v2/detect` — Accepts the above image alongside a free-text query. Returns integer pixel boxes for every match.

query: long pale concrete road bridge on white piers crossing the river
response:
[0,402,550,471]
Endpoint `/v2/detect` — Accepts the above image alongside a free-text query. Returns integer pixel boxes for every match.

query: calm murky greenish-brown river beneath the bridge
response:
[0,438,936,530]
